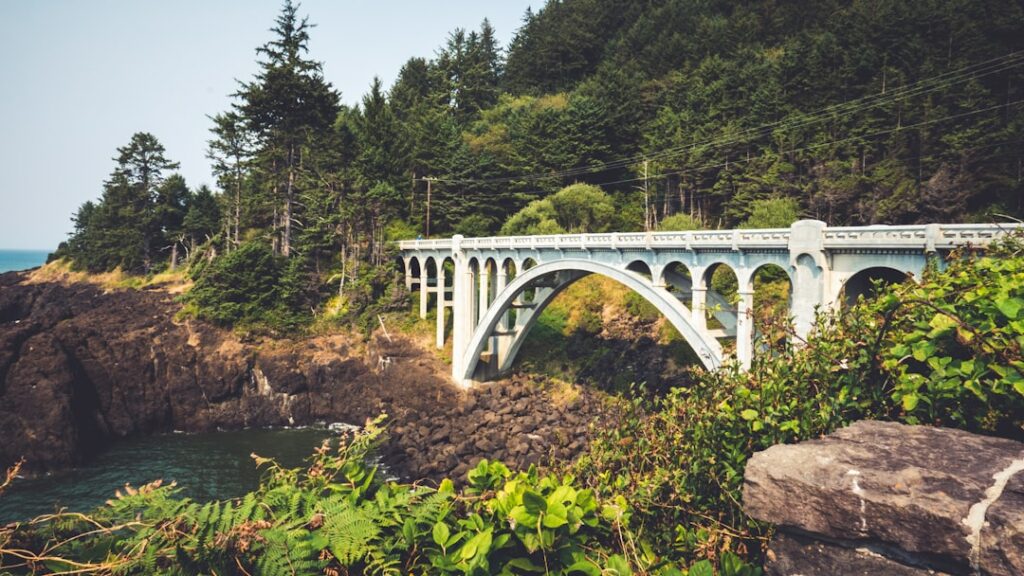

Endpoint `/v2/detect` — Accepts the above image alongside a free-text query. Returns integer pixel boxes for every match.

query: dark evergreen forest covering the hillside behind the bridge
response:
[59,0,1024,323]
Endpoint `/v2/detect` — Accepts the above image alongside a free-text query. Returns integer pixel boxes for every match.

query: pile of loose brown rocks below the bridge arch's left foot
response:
[384,378,613,482]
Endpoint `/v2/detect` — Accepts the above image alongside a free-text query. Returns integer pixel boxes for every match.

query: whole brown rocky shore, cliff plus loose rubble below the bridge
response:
[0,273,602,479]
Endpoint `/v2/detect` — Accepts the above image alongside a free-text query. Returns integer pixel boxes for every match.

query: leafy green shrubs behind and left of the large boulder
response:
[573,241,1024,557]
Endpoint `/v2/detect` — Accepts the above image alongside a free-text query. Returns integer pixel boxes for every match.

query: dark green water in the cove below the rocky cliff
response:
[0,428,332,526]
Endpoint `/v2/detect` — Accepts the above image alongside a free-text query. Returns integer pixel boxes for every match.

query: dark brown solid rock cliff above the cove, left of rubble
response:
[0,274,453,470]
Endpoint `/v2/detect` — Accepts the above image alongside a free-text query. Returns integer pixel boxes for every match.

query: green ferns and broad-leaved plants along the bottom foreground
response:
[0,416,760,576]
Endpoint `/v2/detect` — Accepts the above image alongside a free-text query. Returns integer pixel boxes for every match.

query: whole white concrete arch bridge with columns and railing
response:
[399,220,1019,386]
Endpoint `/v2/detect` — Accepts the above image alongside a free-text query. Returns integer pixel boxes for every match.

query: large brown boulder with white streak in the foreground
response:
[743,421,1024,576]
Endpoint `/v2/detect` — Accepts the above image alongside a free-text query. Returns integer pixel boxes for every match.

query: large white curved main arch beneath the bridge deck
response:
[453,259,722,381]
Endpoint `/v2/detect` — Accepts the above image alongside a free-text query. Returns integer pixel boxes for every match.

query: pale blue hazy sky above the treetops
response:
[0,0,544,249]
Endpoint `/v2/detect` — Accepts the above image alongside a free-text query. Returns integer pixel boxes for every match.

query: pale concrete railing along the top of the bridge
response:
[398,223,1022,251]
